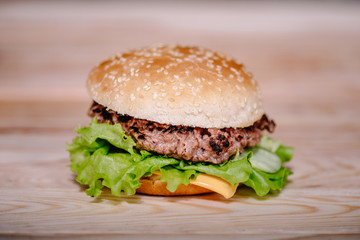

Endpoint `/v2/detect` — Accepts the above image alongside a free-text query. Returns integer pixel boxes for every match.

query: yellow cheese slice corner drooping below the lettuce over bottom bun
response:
[153,171,239,198]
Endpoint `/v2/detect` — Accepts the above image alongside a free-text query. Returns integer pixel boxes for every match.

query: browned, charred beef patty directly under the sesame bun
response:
[88,102,275,164]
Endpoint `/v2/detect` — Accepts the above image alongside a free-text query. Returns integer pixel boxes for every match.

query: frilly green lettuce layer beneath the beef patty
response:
[67,118,293,197]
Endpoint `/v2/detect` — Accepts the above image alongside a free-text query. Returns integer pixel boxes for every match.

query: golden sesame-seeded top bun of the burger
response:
[87,46,264,128]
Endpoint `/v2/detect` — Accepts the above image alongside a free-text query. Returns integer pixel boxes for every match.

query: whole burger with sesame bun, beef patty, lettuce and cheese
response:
[67,45,293,198]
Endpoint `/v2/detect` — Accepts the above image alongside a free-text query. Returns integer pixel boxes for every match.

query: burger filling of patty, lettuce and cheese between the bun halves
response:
[67,103,293,198]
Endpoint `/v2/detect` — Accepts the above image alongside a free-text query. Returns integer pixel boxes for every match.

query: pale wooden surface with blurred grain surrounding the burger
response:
[0,1,360,239]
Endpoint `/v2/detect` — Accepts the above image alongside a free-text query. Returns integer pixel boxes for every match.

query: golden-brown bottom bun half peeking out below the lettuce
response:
[136,178,213,196]
